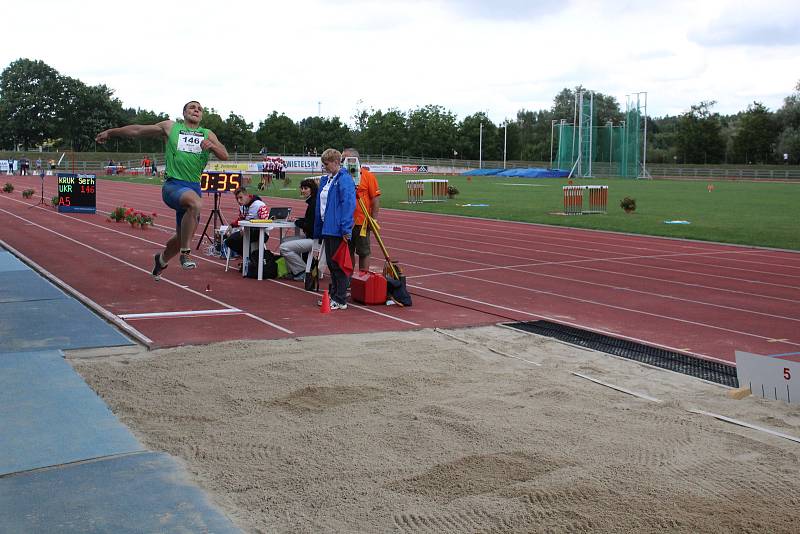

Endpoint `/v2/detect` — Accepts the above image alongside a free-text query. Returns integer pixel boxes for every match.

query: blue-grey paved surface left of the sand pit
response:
[0,248,239,533]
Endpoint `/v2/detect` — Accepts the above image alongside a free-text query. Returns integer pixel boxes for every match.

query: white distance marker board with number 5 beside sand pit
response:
[736,350,800,404]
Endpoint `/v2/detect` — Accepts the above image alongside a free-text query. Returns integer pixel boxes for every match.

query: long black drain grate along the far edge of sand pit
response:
[505,321,739,388]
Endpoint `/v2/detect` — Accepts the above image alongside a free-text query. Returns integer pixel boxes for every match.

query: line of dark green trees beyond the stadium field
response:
[0,59,800,164]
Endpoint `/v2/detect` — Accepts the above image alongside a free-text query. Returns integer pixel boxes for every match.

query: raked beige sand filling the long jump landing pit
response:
[72,326,800,533]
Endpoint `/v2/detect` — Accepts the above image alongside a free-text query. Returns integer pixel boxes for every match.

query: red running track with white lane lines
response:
[0,177,800,362]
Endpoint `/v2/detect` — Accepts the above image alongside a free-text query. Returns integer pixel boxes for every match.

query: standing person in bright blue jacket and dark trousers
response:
[314,148,356,310]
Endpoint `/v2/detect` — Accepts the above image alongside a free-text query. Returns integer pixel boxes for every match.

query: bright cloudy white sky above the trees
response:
[0,0,800,128]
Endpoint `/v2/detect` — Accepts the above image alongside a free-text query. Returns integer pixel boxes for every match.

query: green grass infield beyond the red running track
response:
[102,175,800,250]
